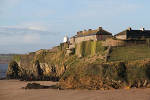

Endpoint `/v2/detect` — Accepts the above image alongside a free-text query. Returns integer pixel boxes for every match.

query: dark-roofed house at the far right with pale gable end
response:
[115,27,150,40]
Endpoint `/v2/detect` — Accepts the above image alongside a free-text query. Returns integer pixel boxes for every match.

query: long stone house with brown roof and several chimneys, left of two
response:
[70,27,112,44]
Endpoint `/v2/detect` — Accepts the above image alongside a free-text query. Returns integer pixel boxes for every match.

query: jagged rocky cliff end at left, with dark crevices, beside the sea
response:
[7,47,65,80]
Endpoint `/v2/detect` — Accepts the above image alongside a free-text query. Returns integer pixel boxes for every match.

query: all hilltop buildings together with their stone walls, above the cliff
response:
[65,27,150,54]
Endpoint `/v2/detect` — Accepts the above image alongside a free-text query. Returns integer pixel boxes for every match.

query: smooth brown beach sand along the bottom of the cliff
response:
[0,80,150,100]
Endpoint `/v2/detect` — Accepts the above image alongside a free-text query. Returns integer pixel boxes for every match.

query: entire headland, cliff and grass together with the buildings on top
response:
[7,27,150,90]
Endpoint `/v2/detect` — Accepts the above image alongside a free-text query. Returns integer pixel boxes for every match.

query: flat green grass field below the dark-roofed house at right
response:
[109,45,150,61]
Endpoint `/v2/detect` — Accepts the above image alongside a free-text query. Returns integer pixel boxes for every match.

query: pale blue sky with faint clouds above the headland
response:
[0,0,150,53]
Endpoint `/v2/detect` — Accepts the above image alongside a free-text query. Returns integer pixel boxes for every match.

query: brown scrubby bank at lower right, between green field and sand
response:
[60,60,150,90]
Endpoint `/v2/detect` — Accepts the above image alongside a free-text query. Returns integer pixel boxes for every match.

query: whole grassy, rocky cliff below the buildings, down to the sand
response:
[7,41,150,90]
